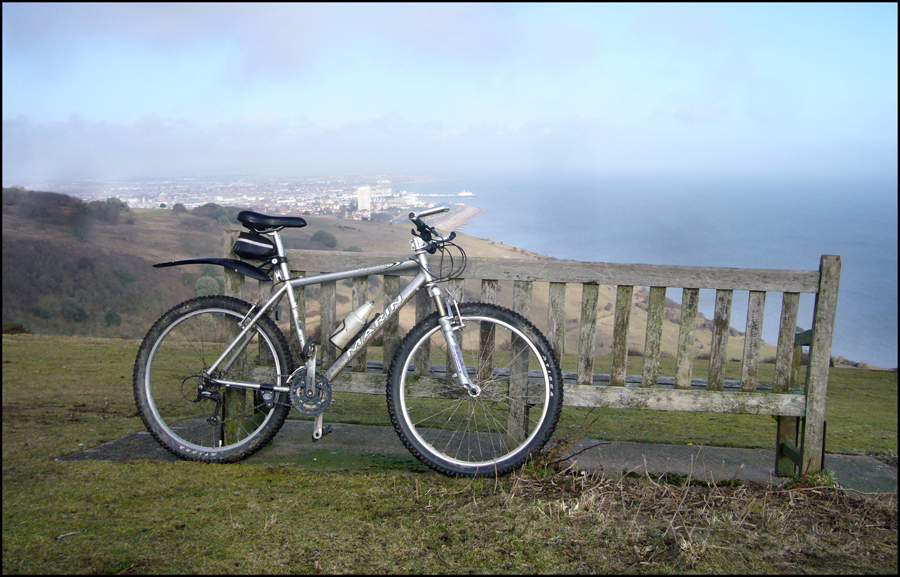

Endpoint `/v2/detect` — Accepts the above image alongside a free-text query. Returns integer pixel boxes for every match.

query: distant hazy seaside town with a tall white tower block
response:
[8,175,475,220]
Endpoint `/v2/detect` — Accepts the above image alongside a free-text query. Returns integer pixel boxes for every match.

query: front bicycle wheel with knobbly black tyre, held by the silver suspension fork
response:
[387,303,562,477]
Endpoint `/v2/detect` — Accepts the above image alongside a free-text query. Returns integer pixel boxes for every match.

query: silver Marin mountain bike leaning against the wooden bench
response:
[134,206,563,477]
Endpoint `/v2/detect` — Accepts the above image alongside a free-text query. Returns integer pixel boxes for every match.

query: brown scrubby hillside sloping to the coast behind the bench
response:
[3,189,774,362]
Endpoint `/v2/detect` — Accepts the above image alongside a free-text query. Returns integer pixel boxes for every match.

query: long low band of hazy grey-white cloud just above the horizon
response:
[3,111,897,185]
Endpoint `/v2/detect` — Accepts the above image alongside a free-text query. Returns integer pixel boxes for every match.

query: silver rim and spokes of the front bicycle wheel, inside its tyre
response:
[399,316,551,469]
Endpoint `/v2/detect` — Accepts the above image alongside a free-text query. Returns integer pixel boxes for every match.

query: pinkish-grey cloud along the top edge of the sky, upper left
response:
[3,3,600,90]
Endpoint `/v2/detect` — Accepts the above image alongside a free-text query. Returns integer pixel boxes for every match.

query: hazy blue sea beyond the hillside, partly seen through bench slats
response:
[410,171,898,368]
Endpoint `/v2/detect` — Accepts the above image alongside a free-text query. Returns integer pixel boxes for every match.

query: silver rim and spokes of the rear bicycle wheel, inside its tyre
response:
[143,308,282,453]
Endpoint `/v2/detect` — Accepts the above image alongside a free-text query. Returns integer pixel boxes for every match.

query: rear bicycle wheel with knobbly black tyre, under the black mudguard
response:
[134,296,293,463]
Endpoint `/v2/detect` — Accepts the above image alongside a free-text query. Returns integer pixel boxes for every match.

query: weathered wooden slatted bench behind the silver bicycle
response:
[226,233,841,476]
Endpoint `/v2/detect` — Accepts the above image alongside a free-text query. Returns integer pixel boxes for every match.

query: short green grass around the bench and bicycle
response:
[3,335,897,574]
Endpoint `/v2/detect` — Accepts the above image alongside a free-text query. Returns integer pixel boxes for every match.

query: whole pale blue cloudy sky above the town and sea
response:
[2,3,898,186]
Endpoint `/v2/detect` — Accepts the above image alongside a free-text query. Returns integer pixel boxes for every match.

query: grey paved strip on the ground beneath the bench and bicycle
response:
[60,419,897,493]
